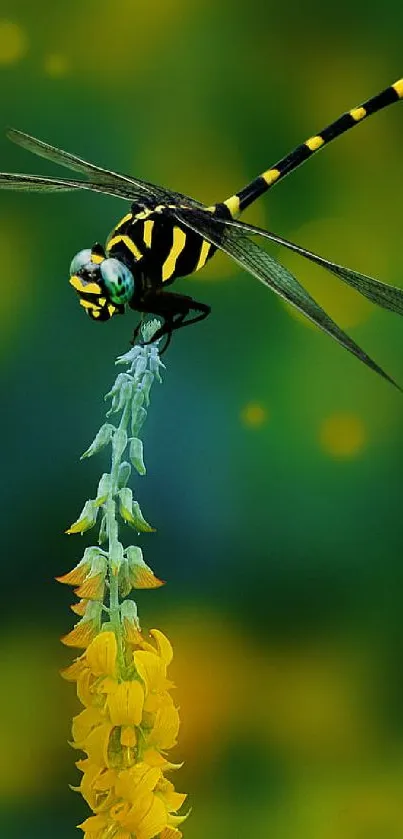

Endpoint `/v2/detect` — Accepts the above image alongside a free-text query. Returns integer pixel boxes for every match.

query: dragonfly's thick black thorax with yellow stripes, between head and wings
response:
[106,204,219,289]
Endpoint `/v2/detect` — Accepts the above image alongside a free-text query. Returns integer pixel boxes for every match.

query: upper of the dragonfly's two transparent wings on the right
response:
[215,219,403,315]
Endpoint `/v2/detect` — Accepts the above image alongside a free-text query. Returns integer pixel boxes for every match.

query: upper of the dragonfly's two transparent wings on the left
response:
[7,128,202,207]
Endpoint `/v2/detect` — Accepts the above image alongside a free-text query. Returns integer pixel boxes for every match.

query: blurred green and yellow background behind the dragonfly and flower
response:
[0,0,403,839]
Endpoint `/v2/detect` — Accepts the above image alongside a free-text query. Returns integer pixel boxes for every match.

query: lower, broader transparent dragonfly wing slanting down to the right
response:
[173,209,401,390]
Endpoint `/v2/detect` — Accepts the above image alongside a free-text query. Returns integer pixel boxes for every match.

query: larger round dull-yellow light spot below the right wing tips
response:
[319,413,367,458]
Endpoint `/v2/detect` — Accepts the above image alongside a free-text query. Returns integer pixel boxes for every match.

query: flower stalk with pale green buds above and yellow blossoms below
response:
[57,321,186,839]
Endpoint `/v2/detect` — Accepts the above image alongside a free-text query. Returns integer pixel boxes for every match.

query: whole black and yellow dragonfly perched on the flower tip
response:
[0,79,403,390]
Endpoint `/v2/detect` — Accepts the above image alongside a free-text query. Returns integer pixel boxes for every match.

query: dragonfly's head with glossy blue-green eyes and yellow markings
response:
[69,245,135,320]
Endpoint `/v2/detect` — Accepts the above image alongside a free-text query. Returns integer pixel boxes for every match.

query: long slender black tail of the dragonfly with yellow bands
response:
[224,79,403,218]
